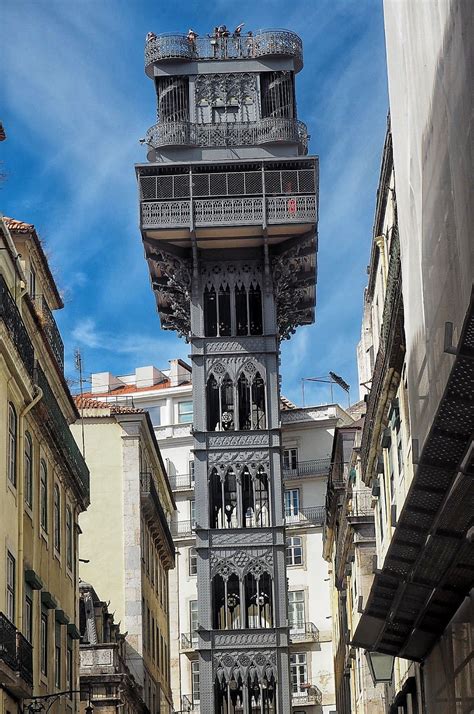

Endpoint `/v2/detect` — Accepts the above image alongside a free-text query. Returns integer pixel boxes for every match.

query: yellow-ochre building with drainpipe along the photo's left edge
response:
[0,218,89,714]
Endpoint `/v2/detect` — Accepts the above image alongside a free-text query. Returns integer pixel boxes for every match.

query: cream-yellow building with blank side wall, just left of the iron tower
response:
[71,397,175,714]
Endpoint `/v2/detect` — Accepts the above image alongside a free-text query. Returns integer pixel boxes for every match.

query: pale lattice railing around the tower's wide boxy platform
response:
[141,196,316,229]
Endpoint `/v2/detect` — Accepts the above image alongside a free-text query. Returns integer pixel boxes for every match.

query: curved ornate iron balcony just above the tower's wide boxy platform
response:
[145,117,309,156]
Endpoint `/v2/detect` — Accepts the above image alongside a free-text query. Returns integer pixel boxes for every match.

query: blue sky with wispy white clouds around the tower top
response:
[0,0,388,404]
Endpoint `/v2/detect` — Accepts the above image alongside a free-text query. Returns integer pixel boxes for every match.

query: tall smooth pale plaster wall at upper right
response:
[384,0,474,452]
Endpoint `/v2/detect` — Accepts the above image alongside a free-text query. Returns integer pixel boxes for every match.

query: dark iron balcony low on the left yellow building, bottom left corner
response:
[0,612,33,697]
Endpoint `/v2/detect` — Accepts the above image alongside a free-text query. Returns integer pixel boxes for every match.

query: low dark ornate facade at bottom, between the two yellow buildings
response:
[79,581,150,714]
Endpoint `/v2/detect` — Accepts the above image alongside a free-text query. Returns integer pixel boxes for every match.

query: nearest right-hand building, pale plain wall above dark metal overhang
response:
[352,0,474,714]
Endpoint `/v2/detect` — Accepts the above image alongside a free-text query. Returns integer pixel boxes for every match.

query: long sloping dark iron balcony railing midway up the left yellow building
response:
[36,363,90,499]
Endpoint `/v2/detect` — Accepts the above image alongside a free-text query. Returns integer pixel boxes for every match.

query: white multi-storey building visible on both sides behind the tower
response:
[84,360,352,714]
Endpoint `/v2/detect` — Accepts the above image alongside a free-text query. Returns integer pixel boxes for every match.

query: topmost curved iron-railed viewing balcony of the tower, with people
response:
[145,30,303,77]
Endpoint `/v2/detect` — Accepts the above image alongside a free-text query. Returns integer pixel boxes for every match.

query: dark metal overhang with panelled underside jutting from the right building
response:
[352,298,474,660]
